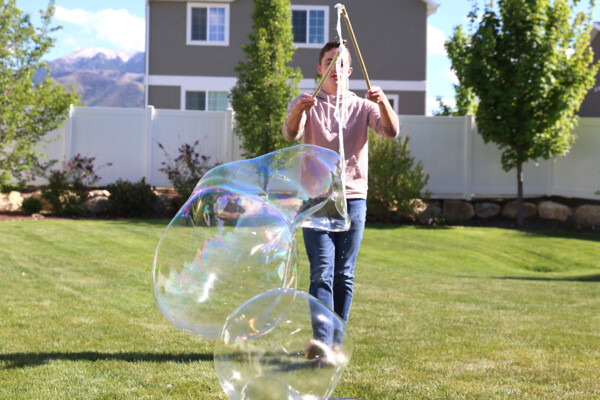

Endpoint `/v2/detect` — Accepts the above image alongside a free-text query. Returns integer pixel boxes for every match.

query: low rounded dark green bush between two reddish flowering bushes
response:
[106,178,157,217]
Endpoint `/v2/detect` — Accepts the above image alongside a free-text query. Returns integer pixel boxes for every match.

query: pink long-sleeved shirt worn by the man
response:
[283,90,400,199]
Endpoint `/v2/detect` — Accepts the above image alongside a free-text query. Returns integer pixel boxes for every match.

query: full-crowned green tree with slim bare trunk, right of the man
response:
[447,0,598,224]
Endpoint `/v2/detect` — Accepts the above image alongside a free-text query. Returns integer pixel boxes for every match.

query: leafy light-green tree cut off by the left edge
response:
[0,0,79,188]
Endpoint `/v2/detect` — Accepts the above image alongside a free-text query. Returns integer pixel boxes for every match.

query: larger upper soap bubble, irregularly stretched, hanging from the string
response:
[153,145,349,339]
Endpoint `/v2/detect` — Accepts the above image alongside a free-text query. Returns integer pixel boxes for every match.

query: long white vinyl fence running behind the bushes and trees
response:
[38,107,600,200]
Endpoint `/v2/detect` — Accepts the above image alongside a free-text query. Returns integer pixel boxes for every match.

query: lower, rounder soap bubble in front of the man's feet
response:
[215,289,353,400]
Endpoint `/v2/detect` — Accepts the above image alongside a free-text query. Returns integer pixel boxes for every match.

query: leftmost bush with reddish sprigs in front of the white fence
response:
[42,154,112,215]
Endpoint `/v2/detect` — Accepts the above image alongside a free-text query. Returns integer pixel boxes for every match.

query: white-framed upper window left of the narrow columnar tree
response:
[187,3,229,46]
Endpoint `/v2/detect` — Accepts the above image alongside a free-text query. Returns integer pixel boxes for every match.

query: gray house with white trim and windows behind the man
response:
[145,0,438,115]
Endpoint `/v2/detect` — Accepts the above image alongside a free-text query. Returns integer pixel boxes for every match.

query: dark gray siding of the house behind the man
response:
[148,0,427,115]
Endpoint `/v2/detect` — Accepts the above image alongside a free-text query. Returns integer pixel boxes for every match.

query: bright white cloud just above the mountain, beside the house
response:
[54,6,146,51]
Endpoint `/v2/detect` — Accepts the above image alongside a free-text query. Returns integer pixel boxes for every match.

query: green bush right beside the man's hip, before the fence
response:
[367,131,429,222]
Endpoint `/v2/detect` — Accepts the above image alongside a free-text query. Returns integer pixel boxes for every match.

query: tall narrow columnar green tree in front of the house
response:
[231,0,301,157]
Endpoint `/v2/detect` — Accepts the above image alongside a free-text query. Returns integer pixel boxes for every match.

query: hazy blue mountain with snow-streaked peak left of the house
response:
[36,47,144,107]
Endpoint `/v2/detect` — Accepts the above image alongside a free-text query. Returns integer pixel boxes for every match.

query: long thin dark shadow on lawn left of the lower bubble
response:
[0,351,213,369]
